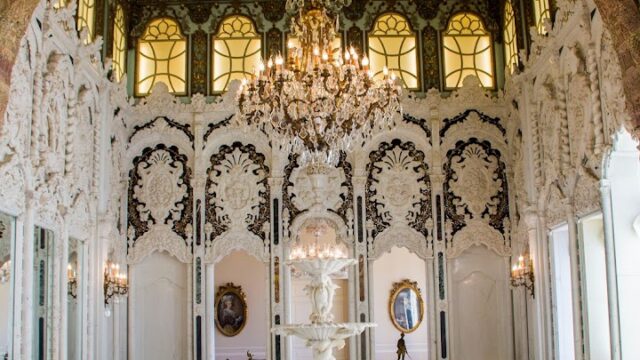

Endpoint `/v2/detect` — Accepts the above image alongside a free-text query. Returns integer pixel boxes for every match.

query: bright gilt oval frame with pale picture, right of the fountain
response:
[389,279,424,334]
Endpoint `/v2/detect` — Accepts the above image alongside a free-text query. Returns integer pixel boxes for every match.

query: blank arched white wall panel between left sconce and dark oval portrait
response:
[129,252,190,360]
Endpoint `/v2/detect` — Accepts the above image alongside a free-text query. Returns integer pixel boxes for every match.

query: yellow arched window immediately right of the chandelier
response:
[369,13,420,90]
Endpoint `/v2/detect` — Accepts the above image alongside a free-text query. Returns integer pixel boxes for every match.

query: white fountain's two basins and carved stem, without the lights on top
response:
[272,258,376,360]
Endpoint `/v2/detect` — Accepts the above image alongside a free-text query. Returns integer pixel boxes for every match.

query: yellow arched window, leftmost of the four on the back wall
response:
[136,18,187,96]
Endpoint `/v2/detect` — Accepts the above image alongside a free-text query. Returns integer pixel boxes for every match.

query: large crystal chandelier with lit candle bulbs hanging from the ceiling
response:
[235,0,401,169]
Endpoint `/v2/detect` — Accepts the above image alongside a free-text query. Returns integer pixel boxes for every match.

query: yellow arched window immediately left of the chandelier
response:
[212,15,262,93]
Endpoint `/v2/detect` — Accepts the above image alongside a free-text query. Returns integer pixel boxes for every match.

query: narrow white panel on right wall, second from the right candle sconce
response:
[580,214,611,359]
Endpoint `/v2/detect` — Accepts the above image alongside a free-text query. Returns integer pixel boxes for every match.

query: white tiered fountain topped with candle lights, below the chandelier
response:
[272,167,376,360]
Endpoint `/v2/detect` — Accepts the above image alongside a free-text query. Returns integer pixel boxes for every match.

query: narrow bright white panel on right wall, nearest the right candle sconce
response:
[549,225,575,360]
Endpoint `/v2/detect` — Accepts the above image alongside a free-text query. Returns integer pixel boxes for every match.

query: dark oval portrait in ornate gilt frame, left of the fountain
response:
[216,283,247,337]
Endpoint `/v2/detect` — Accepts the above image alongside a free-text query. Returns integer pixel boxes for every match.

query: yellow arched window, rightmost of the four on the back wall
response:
[442,13,494,89]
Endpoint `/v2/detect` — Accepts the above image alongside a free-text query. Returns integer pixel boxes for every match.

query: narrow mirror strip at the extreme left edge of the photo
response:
[0,213,15,359]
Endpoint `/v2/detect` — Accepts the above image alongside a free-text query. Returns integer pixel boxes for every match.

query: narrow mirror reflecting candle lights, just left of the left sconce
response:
[67,238,83,360]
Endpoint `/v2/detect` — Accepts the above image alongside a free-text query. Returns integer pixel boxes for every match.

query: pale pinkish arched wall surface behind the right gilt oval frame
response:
[371,247,433,360]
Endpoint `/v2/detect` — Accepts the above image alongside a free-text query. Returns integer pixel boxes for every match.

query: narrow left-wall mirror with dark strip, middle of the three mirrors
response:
[33,226,54,360]
